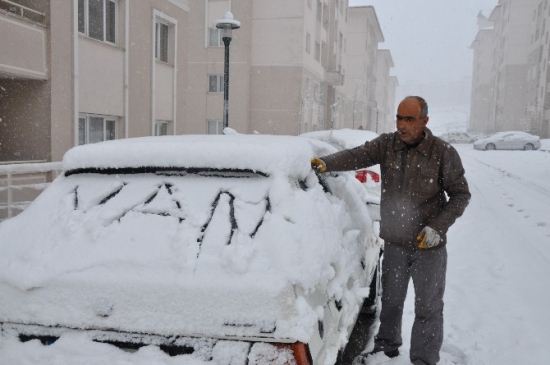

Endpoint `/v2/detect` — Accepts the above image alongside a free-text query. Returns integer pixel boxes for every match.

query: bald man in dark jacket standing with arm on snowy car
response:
[311,96,470,365]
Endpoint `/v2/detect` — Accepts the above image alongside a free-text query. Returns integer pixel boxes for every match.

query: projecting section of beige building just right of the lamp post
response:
[250,0,348,134]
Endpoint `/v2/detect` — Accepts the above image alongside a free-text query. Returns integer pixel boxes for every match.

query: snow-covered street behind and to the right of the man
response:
[372,141,550,365]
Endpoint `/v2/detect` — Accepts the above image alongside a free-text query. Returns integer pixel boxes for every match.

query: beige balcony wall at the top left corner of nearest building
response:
[0,0,48,80]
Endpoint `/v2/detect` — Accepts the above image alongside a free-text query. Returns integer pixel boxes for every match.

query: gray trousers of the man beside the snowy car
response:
[375,243,447,365]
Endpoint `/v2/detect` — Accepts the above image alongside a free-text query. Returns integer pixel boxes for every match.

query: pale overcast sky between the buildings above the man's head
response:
[349,0,498,85]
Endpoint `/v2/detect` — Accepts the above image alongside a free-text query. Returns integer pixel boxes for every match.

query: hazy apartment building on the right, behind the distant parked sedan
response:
[469,0,550,138]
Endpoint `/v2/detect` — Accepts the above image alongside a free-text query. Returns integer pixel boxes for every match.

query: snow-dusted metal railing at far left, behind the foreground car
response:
[0,161,62,221]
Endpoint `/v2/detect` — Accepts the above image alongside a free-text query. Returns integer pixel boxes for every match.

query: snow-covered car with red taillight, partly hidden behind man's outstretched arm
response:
[300,128,382,221]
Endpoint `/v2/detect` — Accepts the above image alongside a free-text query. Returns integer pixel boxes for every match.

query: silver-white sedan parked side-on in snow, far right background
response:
[474,131,540,150]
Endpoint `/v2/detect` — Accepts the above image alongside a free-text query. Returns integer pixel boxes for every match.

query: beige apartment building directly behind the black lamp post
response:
[188,0,348,135]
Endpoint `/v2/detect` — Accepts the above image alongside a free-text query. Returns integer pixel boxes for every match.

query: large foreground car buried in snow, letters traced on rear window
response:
[0,134,380,365]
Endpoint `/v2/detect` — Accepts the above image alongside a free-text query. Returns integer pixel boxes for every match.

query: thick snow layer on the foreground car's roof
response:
[63,134,340,179]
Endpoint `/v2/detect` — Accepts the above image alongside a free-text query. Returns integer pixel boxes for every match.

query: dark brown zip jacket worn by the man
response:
[321,128,470,248]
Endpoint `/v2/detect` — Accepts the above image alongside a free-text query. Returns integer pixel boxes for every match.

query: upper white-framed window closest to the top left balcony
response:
[78,0,117,43]
